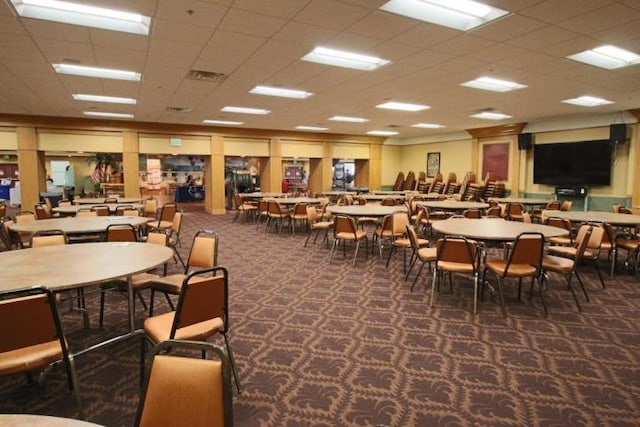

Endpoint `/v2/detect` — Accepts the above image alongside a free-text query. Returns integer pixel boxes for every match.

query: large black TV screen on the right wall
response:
[533,140,611,186]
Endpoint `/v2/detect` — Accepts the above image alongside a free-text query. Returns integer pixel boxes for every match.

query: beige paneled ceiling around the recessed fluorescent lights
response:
[0,0,640,138]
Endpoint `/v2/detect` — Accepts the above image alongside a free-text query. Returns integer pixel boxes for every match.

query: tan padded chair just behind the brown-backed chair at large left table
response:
[149,230,220,316]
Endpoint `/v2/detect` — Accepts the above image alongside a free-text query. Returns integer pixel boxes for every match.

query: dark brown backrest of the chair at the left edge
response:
[0,287,68,373]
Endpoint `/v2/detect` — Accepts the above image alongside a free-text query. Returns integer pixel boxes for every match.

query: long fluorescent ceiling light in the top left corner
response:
[11,0,151,35]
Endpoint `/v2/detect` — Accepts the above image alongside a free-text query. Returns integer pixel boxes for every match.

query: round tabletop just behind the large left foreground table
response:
[9,216,147,236]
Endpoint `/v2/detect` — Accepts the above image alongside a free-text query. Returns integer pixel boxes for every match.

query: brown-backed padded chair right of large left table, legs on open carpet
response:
[140,266,240,393]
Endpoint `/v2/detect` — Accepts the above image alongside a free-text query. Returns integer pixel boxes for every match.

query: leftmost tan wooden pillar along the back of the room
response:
[16,127,47,210]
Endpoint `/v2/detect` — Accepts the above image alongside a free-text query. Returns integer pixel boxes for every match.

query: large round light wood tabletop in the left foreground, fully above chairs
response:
[0,242,173,291]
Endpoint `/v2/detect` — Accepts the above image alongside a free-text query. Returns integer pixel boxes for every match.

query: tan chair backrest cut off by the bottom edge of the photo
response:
[135,340,233,427]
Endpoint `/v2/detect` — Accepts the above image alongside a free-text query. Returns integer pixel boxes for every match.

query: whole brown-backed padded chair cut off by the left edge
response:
[0,287,82,412]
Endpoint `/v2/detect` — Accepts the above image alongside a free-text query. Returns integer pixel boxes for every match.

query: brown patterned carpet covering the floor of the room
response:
[0,205,640,426]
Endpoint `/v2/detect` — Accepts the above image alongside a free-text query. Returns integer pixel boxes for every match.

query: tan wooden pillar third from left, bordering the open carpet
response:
[204,135,227,215]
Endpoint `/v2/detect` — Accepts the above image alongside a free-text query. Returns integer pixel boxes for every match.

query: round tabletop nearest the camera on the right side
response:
[432,218,569,241]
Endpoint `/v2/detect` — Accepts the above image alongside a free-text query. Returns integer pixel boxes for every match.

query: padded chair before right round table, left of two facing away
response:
[429,236,479,313]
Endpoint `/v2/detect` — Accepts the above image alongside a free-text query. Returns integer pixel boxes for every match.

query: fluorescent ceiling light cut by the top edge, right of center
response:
[380,0,509,31]
